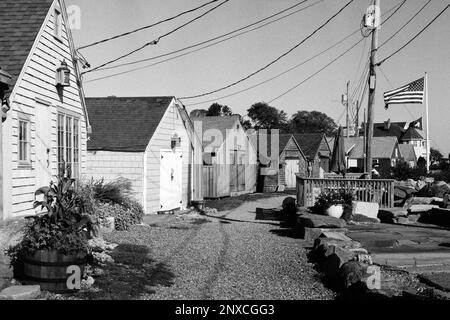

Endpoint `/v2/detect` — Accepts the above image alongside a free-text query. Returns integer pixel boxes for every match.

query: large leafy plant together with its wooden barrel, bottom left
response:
[7,168,93,292]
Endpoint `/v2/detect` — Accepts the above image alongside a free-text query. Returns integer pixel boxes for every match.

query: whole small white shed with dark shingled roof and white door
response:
[86,97,203,214]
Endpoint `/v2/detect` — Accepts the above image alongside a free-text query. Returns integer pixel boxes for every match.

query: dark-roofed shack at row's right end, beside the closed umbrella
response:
[294,133,331,178]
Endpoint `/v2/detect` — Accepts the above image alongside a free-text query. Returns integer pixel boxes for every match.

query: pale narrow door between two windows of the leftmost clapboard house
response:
[33,102,53,188]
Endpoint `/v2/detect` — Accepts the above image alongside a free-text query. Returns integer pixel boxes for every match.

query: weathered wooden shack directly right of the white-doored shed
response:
[191,115,256,198]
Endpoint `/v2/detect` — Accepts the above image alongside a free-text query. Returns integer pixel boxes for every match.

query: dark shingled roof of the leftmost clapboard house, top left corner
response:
[0,0,53,97]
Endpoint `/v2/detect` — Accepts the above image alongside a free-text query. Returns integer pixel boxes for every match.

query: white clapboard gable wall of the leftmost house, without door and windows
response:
[3,0,87,218]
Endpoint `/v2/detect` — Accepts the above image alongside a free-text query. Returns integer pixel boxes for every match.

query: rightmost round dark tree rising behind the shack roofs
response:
[291,111,337,135]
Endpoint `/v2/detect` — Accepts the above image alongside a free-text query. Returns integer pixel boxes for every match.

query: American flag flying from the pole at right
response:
[384,78,424,109]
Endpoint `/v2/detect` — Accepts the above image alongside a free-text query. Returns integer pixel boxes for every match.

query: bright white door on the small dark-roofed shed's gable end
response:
[159,150,183,211]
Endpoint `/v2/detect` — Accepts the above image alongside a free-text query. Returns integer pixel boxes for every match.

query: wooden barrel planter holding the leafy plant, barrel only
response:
[23,250,87,293]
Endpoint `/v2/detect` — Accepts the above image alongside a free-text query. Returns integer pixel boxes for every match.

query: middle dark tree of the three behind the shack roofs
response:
[247,102,288,129]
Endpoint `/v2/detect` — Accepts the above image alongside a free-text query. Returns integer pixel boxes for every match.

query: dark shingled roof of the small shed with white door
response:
[86,96,174,152]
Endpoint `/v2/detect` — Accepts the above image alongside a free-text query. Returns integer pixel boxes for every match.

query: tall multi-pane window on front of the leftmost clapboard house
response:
[58,113,80,179]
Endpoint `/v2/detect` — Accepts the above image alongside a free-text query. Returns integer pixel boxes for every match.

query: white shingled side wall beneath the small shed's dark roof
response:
[84,151,144,205]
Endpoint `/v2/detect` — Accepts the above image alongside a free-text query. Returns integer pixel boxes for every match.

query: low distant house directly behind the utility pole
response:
[344,137,402,176]
